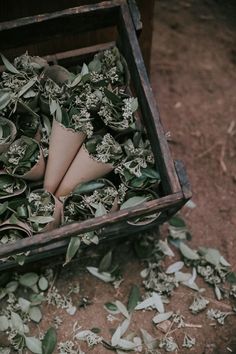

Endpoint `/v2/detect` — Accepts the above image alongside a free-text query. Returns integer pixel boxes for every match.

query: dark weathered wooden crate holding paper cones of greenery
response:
[0,0,191,270]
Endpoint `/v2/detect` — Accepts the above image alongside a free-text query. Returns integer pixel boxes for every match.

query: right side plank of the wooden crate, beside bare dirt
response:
[118,4,181,194]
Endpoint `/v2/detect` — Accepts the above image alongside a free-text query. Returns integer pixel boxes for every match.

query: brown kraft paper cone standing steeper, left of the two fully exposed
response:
[44,119,86,194]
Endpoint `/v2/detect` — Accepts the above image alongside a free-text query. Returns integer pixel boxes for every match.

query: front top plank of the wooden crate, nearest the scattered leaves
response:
[0,192,183,257]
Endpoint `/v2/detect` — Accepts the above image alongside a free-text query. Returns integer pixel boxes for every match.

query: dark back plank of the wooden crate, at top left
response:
[0,0,122,50]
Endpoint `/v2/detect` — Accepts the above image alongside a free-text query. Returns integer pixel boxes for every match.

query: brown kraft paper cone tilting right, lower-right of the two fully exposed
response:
[55,146,114,198]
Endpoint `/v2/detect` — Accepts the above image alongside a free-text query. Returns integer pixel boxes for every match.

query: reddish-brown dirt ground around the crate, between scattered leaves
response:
[1,0,236,354]
